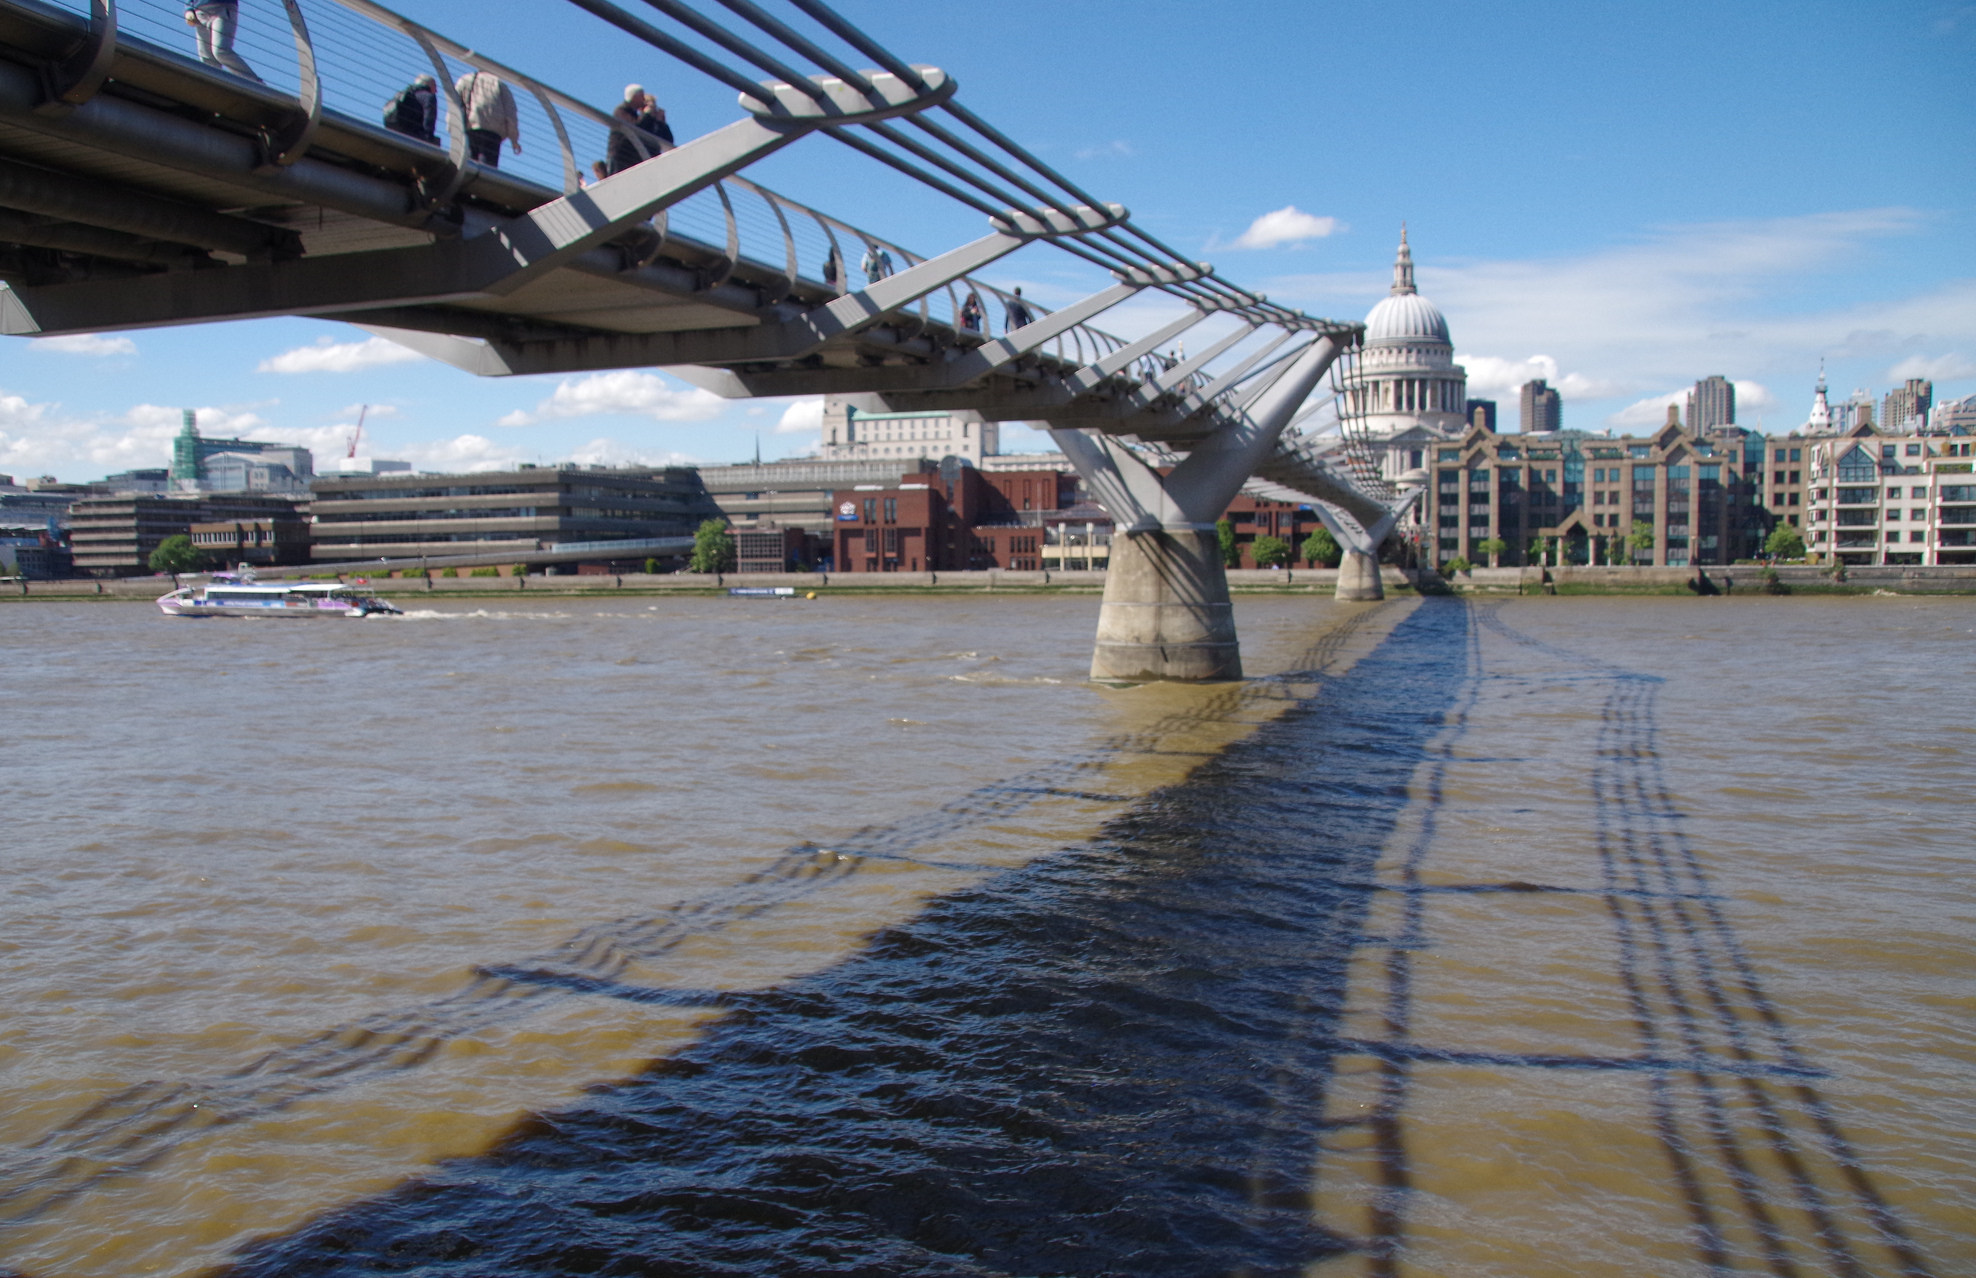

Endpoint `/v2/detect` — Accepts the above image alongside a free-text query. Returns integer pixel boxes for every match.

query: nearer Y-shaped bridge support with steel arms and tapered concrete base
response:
[1051,336,1338,681]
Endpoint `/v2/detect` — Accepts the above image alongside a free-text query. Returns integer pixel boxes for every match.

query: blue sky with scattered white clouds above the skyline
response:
[0,0,1976,480]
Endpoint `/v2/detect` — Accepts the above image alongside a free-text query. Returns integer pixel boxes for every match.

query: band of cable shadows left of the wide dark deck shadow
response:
[0,610,1373,1231]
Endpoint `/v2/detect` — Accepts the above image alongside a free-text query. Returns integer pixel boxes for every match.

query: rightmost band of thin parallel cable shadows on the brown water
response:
[1478,608,1931,1278]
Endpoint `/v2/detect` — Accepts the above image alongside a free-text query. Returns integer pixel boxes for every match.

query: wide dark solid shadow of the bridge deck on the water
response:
[229,599,1474,1278]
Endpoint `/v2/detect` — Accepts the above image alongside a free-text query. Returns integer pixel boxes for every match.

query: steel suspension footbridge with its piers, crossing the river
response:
[0,0,1419,679]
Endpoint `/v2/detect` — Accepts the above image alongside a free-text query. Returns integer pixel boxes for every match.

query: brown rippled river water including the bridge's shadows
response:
[0,597,1976,1278]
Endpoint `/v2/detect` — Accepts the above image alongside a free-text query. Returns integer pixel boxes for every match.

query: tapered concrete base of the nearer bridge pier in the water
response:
[1091,527,1241,683]
